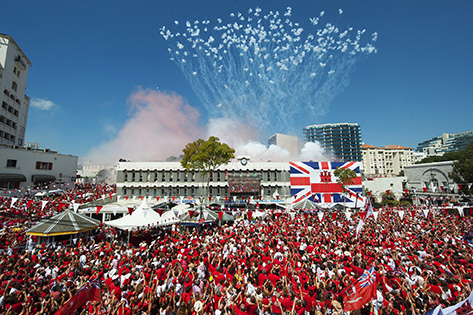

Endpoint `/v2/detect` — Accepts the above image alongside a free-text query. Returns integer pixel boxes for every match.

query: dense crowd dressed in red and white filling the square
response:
[0,183,473,315]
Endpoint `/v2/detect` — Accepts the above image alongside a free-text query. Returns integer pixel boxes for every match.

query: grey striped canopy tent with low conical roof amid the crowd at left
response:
[26,209,100,243]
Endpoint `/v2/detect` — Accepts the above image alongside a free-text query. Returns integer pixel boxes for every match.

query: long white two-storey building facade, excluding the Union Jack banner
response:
[117,158,291,199]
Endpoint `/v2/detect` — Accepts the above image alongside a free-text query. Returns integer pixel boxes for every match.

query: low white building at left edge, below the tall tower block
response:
[0,145,78,189]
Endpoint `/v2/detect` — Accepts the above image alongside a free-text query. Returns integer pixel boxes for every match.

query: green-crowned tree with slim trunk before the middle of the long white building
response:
[181,137,235,201]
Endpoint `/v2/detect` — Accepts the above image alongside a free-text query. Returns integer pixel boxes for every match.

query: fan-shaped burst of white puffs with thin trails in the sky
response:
[161,8,377,134]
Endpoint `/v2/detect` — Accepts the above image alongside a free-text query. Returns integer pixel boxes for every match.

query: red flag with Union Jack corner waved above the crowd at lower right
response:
[340,267,377,312]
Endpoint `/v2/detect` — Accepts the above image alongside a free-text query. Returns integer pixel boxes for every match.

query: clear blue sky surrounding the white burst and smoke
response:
[0,0,473,162]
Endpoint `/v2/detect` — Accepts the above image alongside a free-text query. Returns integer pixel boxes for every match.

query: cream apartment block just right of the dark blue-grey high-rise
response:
[362,144,414,177]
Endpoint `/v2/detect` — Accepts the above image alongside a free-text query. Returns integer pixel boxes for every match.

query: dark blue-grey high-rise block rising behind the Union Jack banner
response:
[304,123,362,161]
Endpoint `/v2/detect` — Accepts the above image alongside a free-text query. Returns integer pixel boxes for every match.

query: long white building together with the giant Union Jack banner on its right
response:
[116,157,363,207]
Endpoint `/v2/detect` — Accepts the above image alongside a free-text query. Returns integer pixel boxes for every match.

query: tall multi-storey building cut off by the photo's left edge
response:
[0,34,31,146]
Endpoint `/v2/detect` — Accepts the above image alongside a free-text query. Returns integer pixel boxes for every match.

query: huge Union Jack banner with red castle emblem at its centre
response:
[289,162,364,206]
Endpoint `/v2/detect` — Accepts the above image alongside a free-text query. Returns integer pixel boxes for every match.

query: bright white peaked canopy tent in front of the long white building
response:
[105,198,179,230]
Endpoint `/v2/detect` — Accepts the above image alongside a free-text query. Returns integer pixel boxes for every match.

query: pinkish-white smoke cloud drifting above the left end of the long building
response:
[86,89,203,164]
